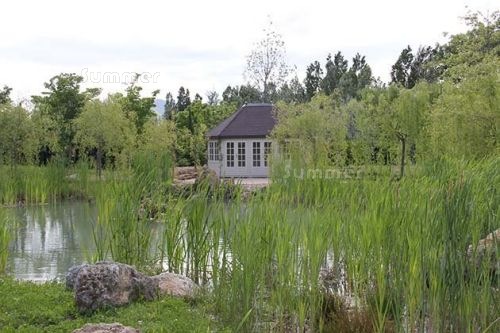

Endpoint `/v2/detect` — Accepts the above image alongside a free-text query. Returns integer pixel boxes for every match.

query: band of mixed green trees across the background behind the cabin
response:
[0,12,500,169]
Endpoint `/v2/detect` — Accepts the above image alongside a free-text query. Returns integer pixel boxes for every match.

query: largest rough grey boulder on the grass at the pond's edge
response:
[66,262,157,312]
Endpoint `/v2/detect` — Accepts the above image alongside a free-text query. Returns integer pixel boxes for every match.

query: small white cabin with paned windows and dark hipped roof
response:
[207,104,276,178]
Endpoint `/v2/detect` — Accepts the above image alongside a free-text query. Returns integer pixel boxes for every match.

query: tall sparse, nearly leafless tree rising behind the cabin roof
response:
[245,22,289,102]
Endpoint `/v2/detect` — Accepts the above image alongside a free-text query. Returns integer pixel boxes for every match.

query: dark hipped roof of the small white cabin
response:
[207,104,276,139]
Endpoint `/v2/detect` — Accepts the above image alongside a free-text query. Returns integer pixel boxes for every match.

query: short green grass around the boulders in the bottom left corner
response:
[0,278,222,333]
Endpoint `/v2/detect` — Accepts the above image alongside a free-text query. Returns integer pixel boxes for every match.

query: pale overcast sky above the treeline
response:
[0,0,498,100]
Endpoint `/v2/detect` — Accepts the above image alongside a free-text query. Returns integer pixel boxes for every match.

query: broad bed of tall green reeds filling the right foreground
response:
[153,158,500,332]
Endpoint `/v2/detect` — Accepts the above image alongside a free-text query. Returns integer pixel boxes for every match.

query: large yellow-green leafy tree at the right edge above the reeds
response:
[429,60,500,159]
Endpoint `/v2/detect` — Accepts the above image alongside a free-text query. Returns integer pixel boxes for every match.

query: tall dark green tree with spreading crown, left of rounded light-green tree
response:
[33,73,100,159]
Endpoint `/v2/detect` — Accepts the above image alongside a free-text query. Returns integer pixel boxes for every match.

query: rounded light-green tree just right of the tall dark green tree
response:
[74,97,136,177]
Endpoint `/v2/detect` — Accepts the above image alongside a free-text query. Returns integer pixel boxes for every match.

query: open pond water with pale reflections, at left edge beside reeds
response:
[7,202,97,281]
